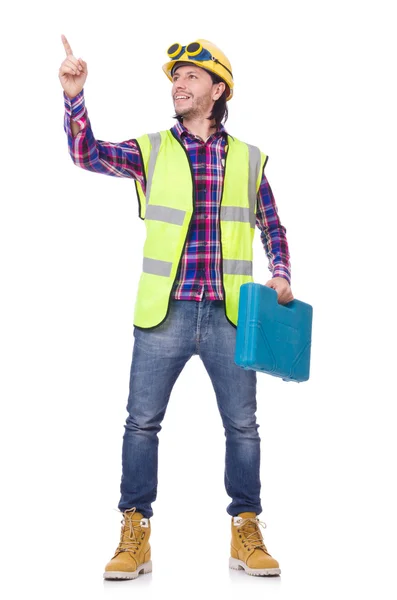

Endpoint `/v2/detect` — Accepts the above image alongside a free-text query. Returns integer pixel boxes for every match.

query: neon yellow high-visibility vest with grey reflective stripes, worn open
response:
[134,129,267,329]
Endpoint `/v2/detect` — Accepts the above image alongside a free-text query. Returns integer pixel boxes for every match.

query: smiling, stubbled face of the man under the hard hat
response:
[172,64,222,119]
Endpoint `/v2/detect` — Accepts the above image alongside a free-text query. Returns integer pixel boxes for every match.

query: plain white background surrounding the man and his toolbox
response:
[0,0,397,600]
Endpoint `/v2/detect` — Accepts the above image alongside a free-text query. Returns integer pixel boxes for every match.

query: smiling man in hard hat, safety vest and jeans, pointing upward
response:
[59,36,293,579]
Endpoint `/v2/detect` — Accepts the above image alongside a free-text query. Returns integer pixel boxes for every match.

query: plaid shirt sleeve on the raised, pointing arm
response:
[63,89,145,192]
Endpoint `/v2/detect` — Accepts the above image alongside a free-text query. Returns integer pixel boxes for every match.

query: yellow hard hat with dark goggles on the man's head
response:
[163,39,234,100]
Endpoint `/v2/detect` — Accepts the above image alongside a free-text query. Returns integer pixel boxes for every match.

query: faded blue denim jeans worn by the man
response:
[118,298,262,518]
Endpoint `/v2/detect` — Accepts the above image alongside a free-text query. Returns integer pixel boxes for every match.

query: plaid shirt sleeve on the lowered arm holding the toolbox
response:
[256,173,291,284]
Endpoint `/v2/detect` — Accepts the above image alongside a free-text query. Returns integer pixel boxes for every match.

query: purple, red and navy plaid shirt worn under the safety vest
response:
[63,90,291,301]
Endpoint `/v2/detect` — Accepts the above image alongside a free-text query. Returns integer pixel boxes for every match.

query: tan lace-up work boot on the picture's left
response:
[103,507,152,579]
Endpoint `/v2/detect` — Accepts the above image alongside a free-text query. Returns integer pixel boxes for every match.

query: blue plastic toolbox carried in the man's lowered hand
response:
[234,283,313,382]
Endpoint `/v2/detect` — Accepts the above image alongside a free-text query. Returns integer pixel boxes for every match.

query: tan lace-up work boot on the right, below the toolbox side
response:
[229,512,281,575]
